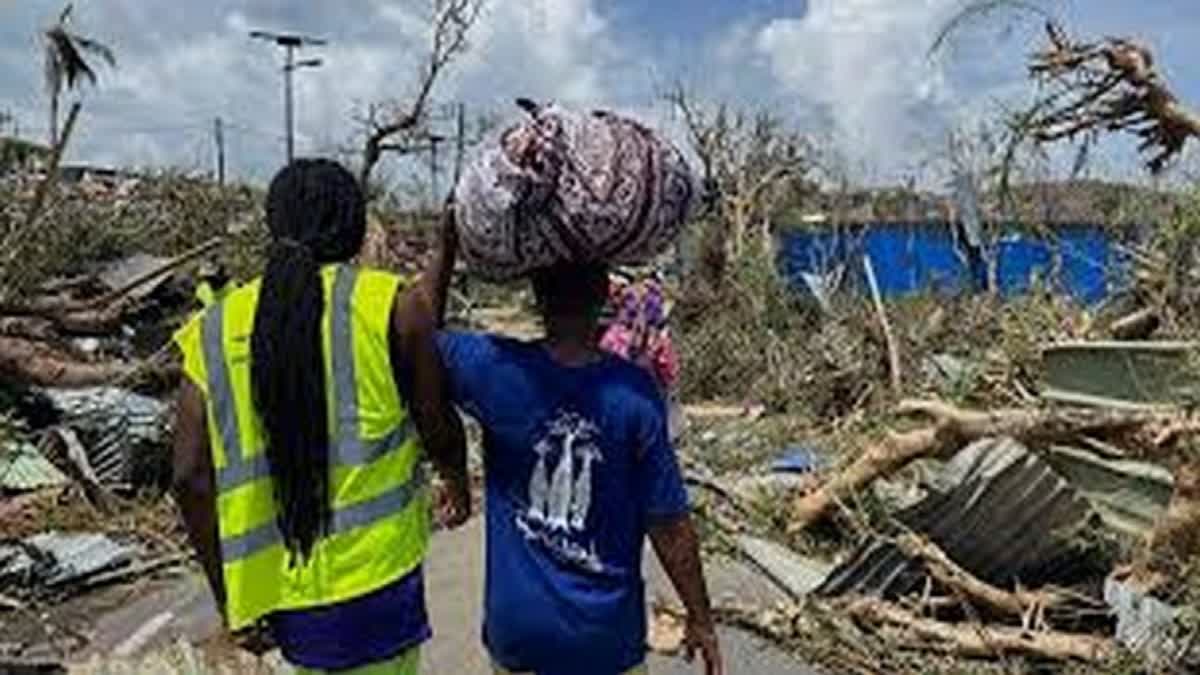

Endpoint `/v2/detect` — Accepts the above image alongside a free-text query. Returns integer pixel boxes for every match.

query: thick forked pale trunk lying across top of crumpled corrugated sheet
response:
[788,401,1153,533]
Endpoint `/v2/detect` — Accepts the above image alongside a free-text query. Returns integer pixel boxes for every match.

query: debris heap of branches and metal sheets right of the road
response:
[672,229,1200,673]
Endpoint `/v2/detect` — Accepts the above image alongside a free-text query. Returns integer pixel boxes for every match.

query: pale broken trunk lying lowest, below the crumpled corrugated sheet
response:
[841,598,1117,663]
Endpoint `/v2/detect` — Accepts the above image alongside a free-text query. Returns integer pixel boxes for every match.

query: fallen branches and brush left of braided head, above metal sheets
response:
[0,107,265,387]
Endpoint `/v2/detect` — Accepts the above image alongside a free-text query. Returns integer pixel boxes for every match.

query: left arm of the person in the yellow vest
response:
[173,378,226,616]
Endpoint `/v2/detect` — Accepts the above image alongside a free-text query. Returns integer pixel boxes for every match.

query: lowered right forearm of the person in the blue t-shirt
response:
[649,515,724,675]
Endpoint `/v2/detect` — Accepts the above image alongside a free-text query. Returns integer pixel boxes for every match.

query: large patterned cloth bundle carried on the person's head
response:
[455,102,697,281]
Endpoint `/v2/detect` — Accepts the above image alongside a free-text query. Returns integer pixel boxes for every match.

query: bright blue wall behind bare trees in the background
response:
[780,222,1123,304]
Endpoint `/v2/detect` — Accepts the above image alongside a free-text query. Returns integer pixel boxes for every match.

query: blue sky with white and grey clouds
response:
[0,0,1200,186]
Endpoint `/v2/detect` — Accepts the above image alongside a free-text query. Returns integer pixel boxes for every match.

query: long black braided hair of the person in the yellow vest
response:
[250,160,366,557]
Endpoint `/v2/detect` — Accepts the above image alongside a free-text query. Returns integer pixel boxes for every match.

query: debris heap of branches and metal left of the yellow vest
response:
[0,119,263,671]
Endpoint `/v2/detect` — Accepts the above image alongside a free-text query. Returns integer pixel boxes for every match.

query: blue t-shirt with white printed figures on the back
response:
[439,333,688,675]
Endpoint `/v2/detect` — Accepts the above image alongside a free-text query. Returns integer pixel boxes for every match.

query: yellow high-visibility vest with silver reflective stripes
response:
[175,265,430,631]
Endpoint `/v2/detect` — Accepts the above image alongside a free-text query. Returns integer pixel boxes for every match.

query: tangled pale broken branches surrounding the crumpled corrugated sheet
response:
[686,400,1200,673]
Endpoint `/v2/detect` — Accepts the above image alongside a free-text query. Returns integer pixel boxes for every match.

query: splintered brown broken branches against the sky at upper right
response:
[1021,22,1200,173]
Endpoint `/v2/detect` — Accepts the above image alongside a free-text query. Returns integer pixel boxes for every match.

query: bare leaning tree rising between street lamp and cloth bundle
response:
[359,0,484,189]
